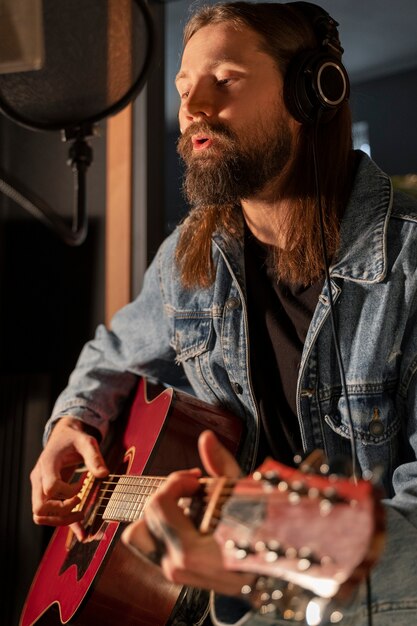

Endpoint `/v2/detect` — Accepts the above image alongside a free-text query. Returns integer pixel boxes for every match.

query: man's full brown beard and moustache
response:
[177,112,292,207]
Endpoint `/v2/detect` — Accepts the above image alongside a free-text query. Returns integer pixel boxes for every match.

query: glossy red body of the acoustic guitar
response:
[20,379,241,626]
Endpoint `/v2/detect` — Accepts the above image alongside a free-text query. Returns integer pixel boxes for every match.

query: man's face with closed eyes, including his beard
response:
[176,23,298,205]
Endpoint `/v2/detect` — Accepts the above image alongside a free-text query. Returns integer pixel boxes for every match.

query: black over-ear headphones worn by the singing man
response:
[284,2,350,124]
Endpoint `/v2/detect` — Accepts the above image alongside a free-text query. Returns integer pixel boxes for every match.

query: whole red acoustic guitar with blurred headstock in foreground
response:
[20,380,384,626]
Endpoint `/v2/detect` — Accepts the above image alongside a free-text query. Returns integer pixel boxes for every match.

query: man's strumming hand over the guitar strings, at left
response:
[30,416,109,540]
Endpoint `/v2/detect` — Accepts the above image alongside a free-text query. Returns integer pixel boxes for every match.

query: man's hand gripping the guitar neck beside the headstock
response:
[122,431,254,595]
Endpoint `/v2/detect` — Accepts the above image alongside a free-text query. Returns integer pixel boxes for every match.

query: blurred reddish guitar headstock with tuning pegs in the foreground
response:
[203,450,383,599]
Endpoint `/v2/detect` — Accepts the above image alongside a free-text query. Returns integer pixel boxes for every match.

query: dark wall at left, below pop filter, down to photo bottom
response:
[0,115,105,626]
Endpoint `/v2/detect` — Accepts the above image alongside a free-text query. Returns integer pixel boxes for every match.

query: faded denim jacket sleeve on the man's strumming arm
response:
[44,236,185,441]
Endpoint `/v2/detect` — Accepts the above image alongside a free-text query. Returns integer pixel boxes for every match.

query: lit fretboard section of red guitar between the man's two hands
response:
[103,475,164,522]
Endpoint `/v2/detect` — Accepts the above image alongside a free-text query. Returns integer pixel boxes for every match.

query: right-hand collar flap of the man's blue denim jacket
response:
[330,153,393,283]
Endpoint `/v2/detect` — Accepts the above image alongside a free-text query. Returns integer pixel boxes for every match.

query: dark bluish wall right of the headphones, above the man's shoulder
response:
[351,69,417,175]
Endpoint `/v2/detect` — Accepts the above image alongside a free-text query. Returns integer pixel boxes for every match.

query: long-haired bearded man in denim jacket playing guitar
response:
[31,3,417,626]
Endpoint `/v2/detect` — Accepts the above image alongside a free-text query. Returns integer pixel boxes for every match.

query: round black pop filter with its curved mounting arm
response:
[0,0,153,245]
